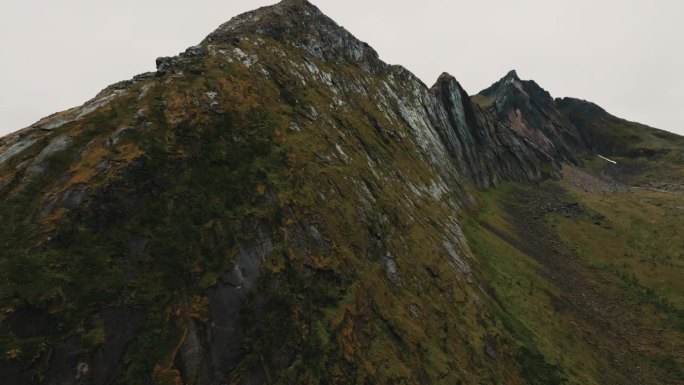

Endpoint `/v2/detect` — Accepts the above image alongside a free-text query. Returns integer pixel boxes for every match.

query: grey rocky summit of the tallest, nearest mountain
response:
[203,0,387,73]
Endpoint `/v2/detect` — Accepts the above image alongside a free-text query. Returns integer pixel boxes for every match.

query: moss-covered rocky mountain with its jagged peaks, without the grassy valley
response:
[0,0,680,385]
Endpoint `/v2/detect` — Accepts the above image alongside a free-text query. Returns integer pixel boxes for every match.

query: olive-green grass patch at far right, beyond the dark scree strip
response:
[554,184,684,307]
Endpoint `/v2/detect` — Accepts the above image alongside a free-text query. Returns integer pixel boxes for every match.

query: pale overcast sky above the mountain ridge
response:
[0,0,684,135]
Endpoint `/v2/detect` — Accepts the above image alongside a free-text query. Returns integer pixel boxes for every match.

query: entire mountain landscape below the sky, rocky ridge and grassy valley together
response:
[0,0,684,385]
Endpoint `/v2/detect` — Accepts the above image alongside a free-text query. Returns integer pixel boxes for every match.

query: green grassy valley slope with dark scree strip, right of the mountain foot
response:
[464,170,684,384]
